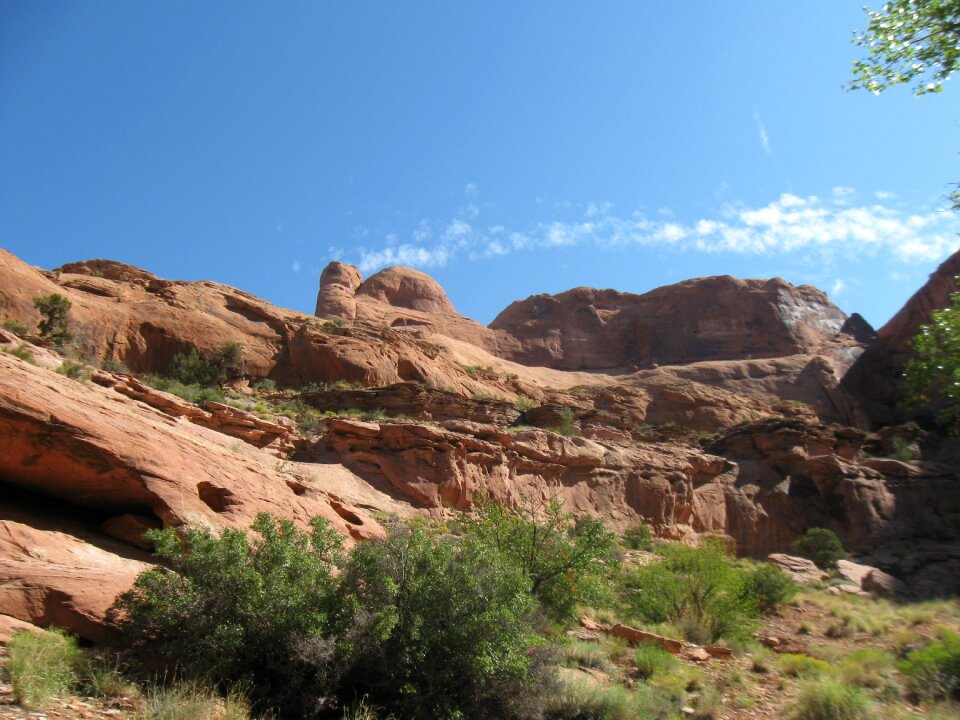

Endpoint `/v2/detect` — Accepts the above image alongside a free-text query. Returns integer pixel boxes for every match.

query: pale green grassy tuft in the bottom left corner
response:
[6,630,84,708]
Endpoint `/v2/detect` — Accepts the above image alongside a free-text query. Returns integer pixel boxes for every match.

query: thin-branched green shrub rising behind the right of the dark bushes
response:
[463,499,615,617]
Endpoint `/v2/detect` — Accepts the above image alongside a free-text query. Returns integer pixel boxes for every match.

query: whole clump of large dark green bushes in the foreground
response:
[111,503,612,718]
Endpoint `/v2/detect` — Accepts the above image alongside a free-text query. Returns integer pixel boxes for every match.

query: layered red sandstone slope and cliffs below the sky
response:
[0,246,960,640]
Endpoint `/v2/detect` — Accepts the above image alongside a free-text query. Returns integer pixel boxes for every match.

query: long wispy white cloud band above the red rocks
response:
[357,187,960,272]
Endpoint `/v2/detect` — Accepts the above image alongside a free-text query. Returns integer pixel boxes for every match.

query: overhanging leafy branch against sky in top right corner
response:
[848,0,960,95]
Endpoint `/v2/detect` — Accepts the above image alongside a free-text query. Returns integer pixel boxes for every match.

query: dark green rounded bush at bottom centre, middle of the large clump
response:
[330,526,536,718]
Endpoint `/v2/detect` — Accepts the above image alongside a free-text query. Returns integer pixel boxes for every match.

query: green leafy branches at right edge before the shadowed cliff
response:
[904,293,960,435]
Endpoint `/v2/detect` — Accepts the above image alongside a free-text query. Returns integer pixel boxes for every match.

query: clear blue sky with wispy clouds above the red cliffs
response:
[0,0,960,325]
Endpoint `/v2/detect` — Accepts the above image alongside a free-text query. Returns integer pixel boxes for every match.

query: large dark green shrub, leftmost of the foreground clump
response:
[110,514,342,715]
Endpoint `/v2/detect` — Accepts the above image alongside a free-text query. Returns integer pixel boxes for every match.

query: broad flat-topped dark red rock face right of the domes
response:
[490,276,854,370]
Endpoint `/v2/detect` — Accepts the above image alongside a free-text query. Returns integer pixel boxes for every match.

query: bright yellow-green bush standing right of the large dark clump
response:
[623,541,757,642]
